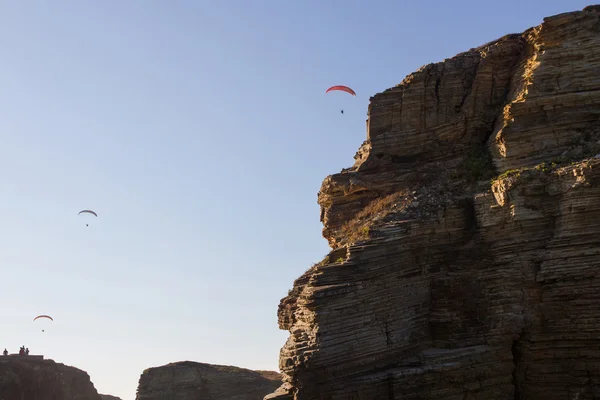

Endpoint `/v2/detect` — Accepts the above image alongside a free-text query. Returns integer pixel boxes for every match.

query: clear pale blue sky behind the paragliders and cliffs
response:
[0,0,590,400]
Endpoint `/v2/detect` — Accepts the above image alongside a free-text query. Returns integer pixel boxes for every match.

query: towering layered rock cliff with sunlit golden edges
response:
[265,6,600,400]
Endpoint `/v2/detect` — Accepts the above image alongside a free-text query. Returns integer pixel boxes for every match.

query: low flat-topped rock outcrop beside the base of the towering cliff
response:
[136,361,281,400]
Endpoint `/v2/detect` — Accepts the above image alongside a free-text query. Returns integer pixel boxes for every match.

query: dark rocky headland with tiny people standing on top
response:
[0,356,102,400]
